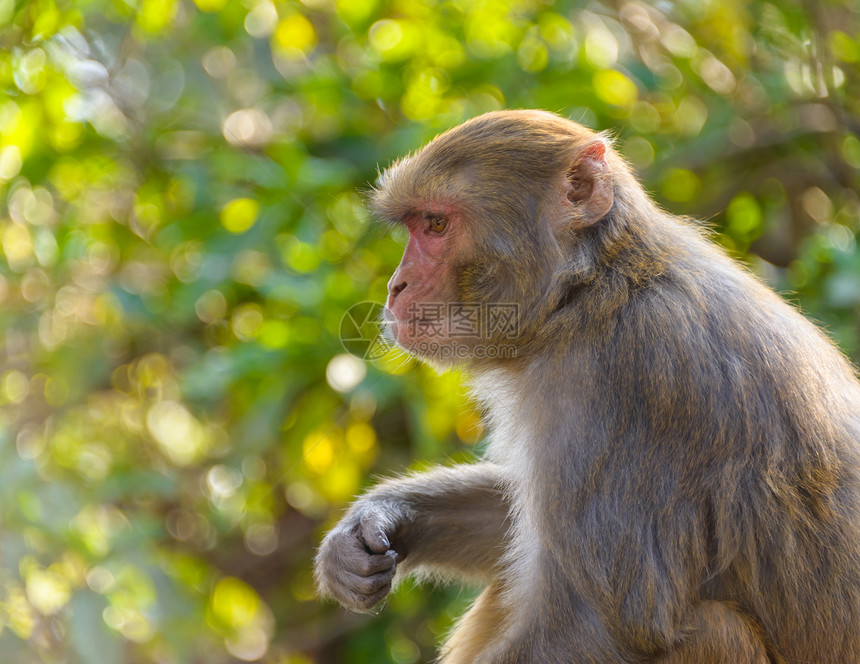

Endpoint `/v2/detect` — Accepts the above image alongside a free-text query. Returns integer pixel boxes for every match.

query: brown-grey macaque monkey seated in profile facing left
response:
[316,111,860,664]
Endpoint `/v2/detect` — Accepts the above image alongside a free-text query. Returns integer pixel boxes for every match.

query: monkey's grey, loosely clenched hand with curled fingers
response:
[314,499,401,611]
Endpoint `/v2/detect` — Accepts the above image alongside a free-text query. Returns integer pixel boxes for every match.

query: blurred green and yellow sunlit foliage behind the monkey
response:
[0,0,860,664]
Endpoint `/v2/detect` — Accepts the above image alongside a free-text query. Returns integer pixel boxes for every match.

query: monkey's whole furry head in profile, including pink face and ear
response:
[371,111,624,366]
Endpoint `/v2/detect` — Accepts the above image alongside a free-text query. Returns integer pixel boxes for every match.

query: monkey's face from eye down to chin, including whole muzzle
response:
[383,205,481,365]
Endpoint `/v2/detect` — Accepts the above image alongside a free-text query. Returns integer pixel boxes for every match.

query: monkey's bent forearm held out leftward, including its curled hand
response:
[315,463,509,609]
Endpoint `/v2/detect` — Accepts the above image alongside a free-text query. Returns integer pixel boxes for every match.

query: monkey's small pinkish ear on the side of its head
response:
[567,137,613,227]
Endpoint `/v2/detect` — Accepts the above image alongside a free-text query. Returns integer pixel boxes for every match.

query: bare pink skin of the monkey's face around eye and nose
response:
[384,206,463,355]
